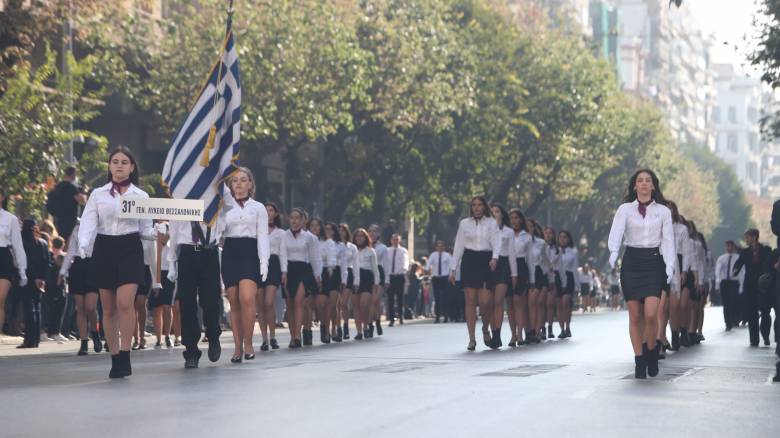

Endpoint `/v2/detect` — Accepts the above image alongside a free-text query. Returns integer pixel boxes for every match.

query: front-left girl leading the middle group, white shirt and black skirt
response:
[450,196,501,351]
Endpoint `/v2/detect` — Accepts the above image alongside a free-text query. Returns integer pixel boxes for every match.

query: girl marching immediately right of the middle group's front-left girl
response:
[488,203,517,350]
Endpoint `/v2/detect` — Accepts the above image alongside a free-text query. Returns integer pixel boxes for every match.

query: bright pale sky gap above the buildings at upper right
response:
[685,0,759,73]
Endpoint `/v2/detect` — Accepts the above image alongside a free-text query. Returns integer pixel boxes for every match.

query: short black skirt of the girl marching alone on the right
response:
[620,246,666,301]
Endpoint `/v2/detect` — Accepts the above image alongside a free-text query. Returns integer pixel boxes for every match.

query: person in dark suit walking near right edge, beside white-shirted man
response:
[734,228,773,347]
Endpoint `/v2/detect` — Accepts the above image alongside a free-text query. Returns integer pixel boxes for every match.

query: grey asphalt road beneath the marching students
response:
[0,308,780,438]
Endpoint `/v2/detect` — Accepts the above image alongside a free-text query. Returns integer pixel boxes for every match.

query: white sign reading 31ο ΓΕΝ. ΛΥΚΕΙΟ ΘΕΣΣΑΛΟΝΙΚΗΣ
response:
[119,196,205,221]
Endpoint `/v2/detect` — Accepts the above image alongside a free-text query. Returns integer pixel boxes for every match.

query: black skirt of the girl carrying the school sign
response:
[89,233,146,290]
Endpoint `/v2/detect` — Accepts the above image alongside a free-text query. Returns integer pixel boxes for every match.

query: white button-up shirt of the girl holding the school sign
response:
[78,182,156,255]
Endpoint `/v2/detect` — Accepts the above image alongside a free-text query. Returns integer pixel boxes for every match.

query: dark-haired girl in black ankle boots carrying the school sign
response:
[77,146,160,378]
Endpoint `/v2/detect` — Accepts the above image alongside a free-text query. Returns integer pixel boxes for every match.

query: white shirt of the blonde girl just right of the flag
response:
[217,198,271,266]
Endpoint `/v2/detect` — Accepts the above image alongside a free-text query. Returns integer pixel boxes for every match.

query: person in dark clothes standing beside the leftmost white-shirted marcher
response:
[17,219,51,348]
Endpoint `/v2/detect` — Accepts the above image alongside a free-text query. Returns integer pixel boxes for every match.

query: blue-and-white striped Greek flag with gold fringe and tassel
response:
[162,18,241,223]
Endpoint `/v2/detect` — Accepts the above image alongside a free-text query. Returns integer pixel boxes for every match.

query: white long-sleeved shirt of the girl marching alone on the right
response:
[608,201,677,275]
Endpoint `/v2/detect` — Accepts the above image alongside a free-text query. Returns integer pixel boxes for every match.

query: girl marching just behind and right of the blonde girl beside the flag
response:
[257,202,287,351]
